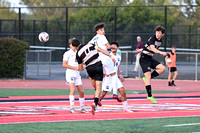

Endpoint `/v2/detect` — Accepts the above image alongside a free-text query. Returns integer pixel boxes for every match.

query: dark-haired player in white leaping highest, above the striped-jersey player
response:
[89,23,121,101]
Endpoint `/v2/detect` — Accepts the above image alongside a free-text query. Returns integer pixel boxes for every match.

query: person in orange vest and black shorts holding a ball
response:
[165,46,178,86]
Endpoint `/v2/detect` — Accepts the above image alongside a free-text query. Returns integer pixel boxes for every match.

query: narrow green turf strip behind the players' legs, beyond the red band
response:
[0,89,197,97]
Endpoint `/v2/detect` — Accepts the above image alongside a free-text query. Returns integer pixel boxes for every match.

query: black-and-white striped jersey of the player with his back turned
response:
[76,44,100,66]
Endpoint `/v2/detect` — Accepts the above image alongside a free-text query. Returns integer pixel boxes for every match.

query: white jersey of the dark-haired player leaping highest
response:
[89,34,108,58]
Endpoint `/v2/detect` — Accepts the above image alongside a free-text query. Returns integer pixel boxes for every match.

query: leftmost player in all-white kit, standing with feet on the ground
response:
[63,38,87,113]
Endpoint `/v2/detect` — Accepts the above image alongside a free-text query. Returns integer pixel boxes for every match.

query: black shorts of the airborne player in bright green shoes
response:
[140,54,160,73]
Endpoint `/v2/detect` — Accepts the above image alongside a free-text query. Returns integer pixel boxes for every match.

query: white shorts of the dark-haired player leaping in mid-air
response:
[100,56,115,75]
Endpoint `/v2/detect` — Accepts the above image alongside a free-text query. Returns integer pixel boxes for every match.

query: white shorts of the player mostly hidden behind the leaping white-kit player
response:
[102,77,124,92]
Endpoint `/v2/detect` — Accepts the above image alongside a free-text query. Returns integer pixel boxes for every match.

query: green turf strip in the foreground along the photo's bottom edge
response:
[0,116,200,133]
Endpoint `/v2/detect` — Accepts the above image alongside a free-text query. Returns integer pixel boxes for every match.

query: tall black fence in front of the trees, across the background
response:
[0,6,200,50]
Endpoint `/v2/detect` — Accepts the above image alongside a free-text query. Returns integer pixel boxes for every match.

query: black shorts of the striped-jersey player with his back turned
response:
[86,61,103,81]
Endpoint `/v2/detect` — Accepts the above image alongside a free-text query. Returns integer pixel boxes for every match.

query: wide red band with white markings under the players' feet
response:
[0,98,200,124]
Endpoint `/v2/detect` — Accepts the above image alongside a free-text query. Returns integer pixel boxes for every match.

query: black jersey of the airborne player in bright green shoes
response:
[142,35,162,56]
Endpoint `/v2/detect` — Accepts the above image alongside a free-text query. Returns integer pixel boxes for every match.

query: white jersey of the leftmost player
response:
[63,49,80,77]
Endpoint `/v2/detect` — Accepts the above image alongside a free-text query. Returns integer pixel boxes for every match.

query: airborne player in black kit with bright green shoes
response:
[140,26,166,104]
